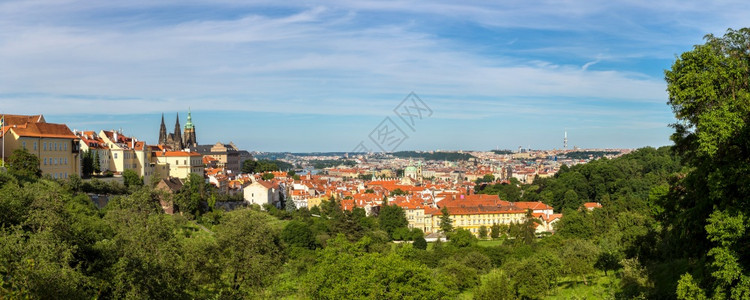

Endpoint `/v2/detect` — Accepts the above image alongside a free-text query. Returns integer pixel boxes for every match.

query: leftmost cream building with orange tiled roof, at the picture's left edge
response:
[0,115,81,178]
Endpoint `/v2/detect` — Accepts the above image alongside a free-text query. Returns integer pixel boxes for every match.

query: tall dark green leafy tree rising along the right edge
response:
[663,28,750,298]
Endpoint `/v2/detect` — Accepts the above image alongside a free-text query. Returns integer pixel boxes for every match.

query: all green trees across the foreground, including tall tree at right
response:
[0,29,750,299]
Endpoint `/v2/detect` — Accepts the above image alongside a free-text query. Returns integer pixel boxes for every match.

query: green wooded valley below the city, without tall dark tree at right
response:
[0,148,676,299]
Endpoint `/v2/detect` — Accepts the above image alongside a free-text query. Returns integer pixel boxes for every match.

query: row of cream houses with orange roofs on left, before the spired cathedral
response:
[0,115,212,182]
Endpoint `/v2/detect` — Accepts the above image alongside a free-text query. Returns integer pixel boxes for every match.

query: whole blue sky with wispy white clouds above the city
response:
[0,0,750,152]
